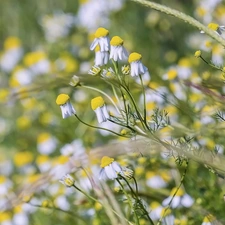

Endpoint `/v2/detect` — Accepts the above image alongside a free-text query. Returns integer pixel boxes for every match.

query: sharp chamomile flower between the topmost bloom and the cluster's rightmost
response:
[109,36,128,61]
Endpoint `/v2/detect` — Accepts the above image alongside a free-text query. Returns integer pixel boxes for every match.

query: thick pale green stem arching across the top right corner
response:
[131,0,225,47]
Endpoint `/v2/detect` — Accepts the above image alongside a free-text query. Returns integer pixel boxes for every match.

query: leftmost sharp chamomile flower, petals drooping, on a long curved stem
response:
[56,94,76,119]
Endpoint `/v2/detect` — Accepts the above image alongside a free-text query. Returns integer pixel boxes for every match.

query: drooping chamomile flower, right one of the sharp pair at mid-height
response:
[91,96,110,123]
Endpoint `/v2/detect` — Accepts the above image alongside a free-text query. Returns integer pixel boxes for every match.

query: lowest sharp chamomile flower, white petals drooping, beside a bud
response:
[99,156,122,180]
